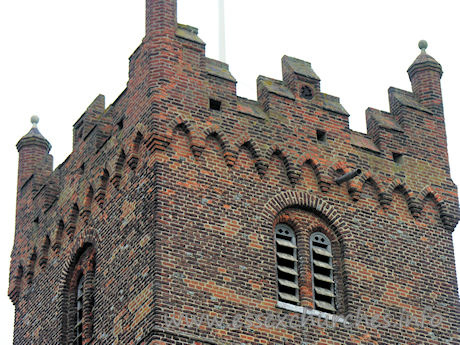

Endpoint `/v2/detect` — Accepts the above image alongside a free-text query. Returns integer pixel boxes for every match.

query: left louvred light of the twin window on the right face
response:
[275,224,300,305]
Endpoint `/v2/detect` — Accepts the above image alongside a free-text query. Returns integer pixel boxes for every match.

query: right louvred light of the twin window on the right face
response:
[310,232,336,313]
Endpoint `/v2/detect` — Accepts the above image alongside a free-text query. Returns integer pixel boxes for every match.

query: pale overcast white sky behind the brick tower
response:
[0,0,460,344]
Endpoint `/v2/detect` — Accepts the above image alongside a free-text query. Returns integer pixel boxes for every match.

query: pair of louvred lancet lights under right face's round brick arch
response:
[275,224,336,313]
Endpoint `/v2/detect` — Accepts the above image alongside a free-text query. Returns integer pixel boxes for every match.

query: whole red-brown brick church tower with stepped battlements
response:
[9,0,460,345]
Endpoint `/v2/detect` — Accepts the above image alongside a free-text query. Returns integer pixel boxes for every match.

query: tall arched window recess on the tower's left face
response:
[62,244,96,345]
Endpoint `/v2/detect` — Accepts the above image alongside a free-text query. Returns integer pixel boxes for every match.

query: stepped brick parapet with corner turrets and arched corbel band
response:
[9,4,460,330]
